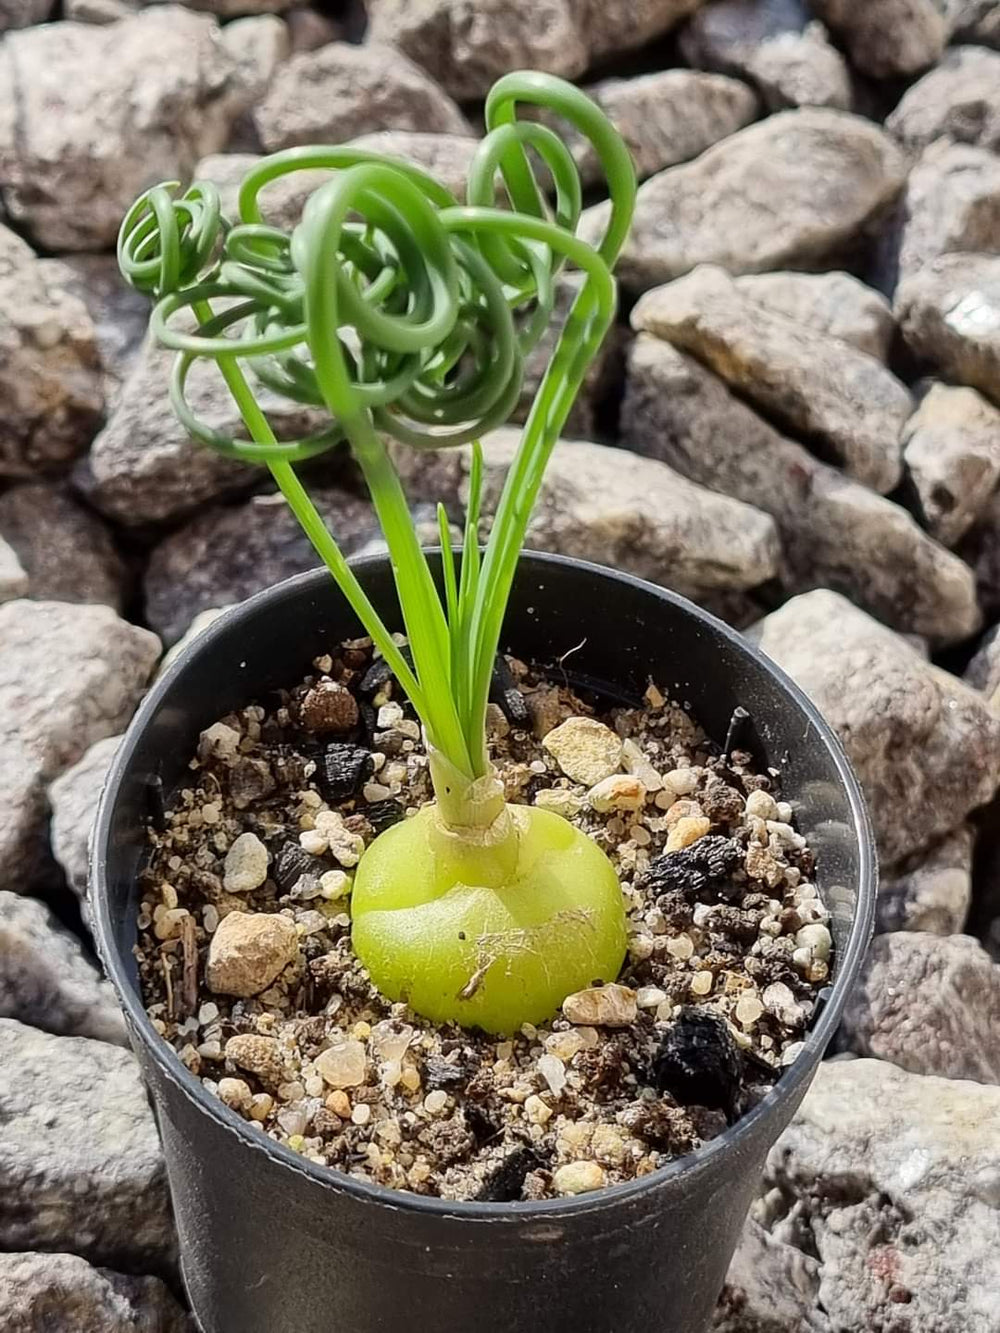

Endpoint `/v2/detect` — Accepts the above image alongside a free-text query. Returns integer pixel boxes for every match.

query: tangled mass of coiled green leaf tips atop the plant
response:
[119,75,635,464]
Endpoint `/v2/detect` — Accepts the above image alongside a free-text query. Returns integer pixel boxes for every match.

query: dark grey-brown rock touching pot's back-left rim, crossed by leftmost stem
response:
[145,489,379,644]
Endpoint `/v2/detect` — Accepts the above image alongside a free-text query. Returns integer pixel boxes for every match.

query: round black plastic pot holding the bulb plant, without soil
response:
[91,555,876,1333]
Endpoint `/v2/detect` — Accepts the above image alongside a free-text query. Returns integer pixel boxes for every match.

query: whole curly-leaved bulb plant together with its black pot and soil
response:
[92,73,875,1333]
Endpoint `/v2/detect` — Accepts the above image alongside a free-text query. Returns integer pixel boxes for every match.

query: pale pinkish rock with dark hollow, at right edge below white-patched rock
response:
[903,384,1000,547]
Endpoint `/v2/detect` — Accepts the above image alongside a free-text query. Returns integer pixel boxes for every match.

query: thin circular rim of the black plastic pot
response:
[88,551,877,1222]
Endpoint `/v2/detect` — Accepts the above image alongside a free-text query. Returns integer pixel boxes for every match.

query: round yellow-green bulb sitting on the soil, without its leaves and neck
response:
[352,805,625,1034]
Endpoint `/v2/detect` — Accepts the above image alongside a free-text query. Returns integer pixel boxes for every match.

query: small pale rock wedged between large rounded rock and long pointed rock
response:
[736,271,895,361]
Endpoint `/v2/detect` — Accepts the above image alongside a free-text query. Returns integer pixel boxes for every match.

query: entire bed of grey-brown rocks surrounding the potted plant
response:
[0,0,1000,1333]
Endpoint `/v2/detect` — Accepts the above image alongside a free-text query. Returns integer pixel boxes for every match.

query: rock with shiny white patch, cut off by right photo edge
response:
[895,255,1000,404]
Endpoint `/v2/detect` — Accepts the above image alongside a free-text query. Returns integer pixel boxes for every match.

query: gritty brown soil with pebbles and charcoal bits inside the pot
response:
[137,640,831,1201]
